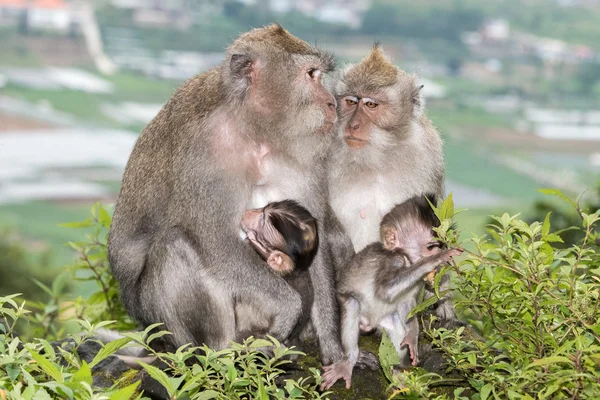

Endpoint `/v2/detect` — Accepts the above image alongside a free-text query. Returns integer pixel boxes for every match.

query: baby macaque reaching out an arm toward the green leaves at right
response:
[321,196,462,390]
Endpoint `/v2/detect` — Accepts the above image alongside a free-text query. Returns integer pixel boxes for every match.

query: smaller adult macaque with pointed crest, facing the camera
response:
[328,45,456,320]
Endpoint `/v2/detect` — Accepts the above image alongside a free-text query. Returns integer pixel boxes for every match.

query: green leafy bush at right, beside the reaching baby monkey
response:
[382,190,600,400]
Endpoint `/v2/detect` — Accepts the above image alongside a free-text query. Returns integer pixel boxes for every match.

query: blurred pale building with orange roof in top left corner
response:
[0,0,73,33]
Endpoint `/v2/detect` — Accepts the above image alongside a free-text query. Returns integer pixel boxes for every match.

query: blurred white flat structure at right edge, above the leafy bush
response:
[525,108,600,140]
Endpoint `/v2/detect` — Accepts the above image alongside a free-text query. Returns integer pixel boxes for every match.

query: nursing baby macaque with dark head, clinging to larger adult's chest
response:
[236,200,319,340]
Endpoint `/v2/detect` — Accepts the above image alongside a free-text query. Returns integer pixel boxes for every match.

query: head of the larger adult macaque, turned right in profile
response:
[223,25,337,137]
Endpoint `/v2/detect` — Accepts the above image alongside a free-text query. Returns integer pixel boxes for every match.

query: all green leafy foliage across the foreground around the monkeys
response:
[0,190,600,400]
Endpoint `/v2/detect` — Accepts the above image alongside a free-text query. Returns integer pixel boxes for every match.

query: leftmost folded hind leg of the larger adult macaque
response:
[134,228,235,349]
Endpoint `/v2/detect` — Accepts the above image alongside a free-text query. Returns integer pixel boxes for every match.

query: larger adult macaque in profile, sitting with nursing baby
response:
[108,25,342,364]
